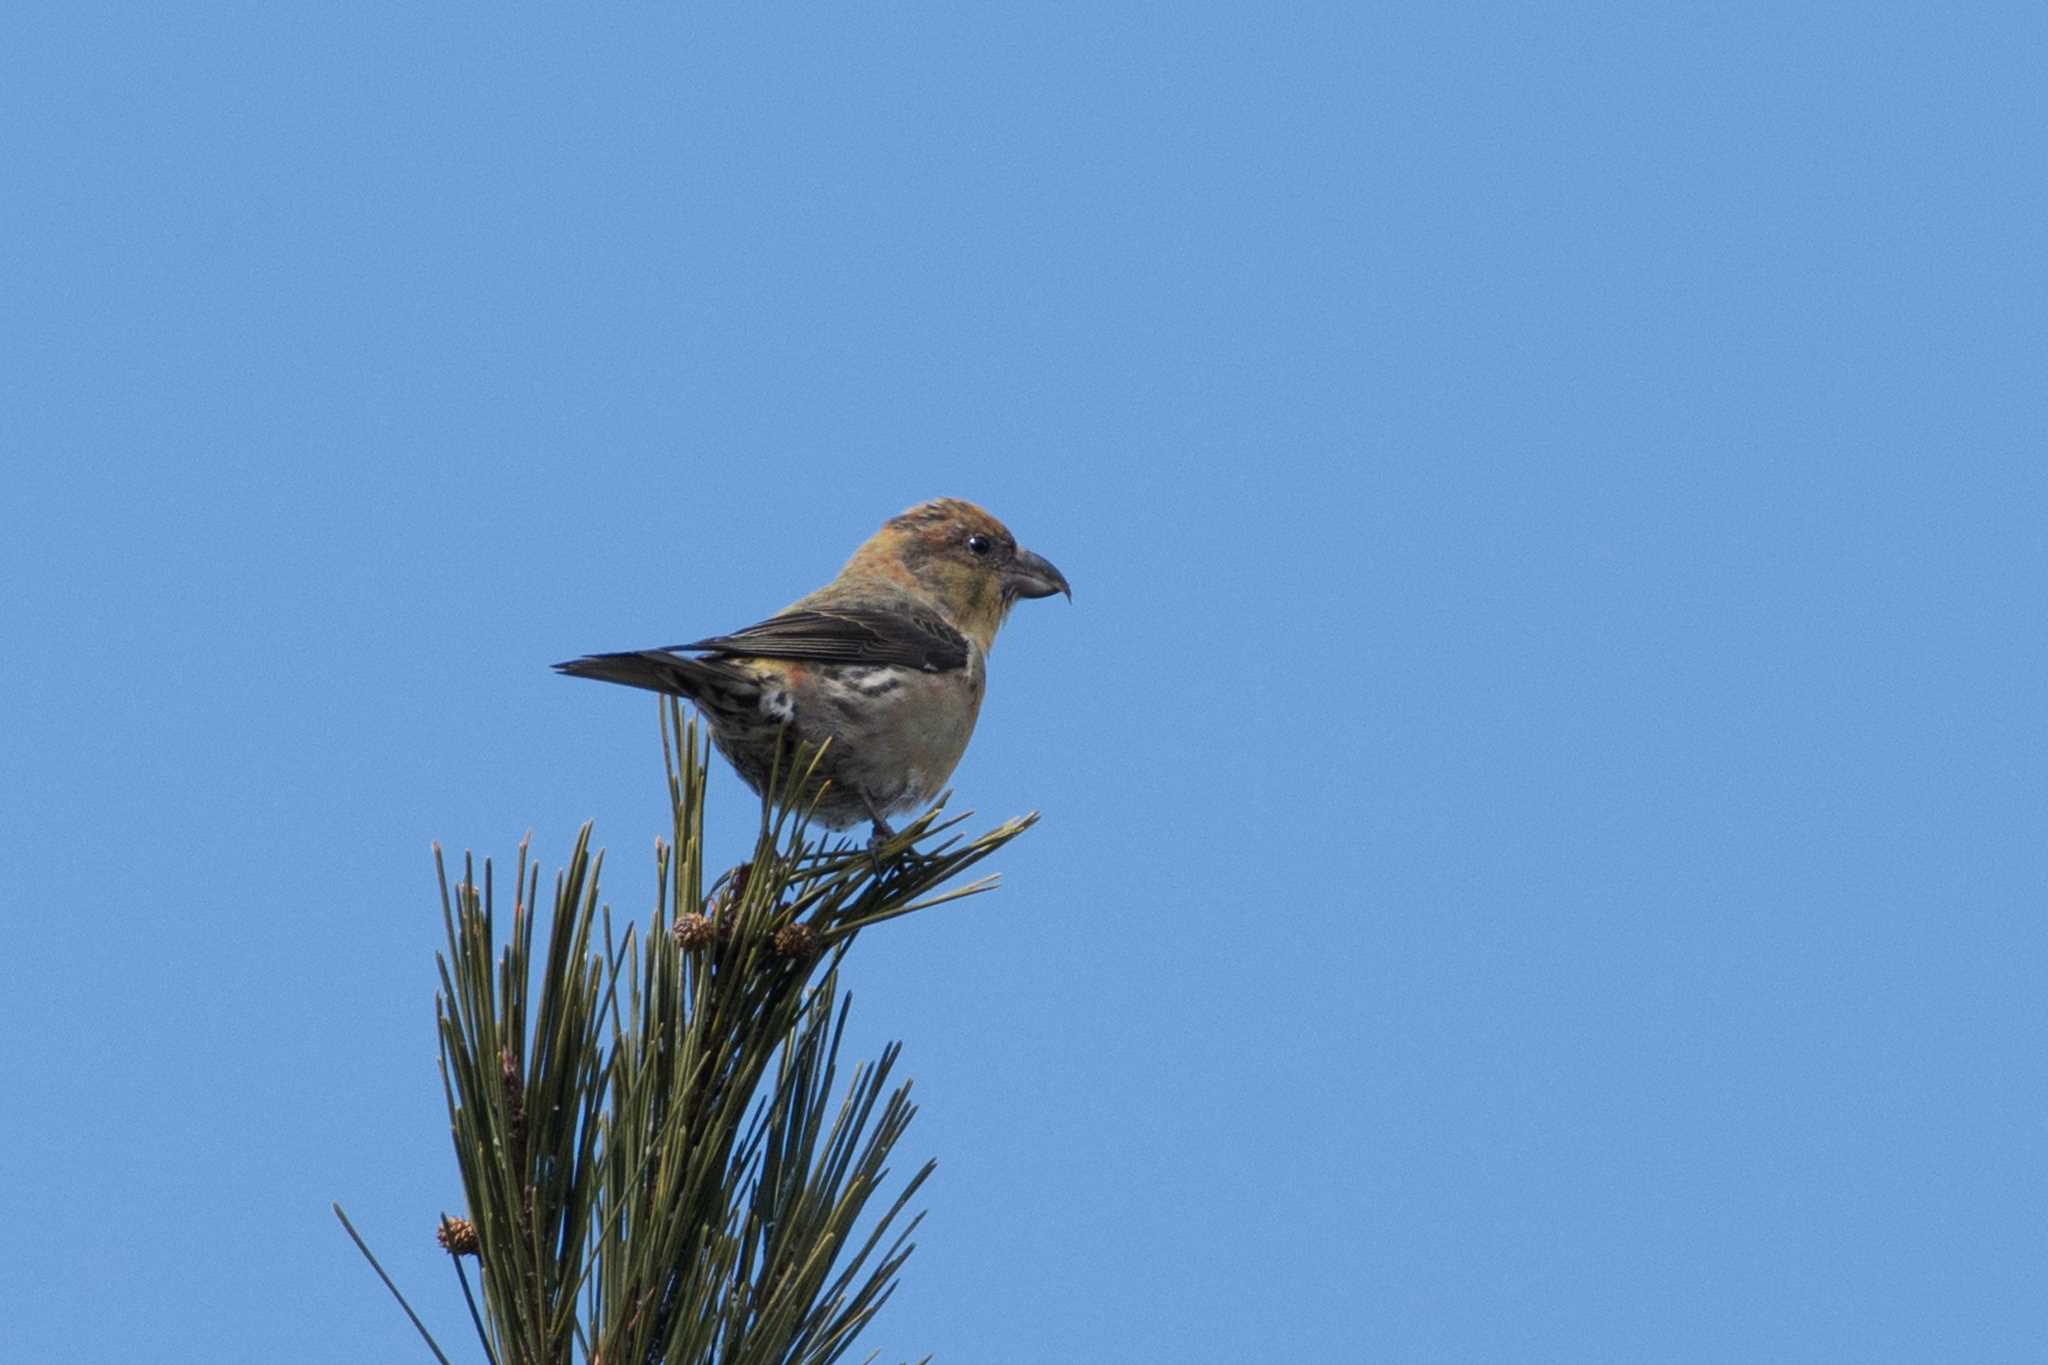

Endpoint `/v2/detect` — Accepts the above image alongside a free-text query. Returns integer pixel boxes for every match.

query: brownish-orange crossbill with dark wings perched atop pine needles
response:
[555,497,1073,847]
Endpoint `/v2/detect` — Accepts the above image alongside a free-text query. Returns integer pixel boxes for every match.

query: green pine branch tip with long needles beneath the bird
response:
[346,702,1036,1365]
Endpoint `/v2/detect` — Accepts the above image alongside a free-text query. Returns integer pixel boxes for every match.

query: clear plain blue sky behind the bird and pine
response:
[0,4,2048,1363]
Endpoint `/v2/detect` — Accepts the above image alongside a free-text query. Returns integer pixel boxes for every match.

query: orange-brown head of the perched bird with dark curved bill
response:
[846,497,1073,649]
